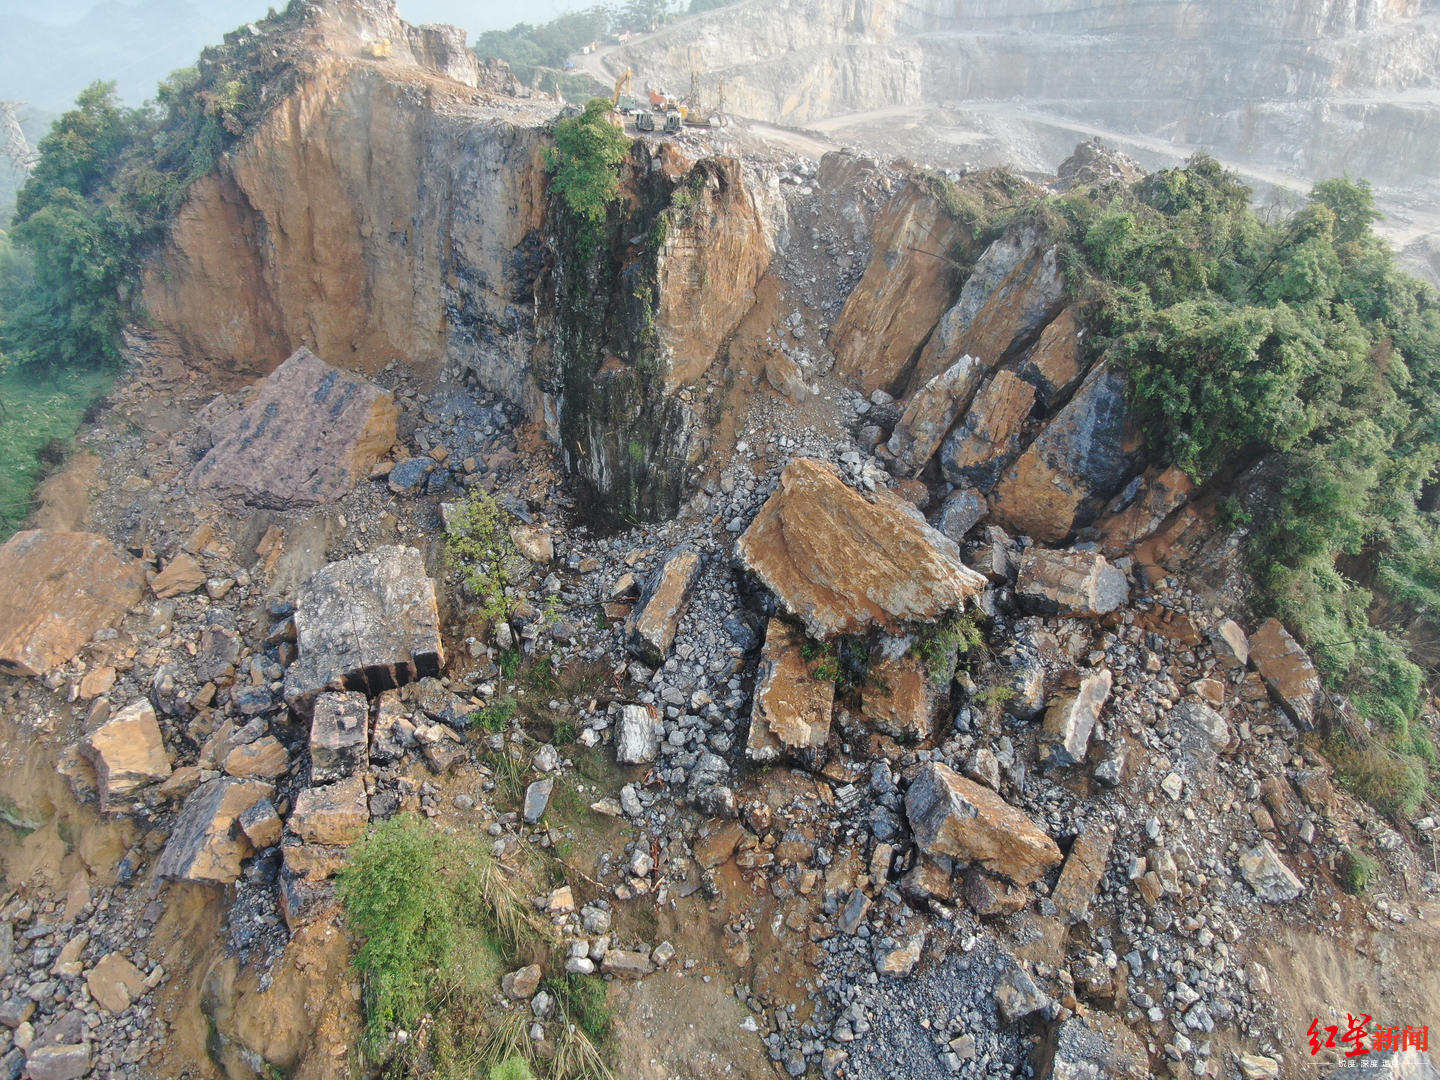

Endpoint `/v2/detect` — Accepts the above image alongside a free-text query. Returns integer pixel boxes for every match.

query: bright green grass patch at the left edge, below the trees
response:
[0,370,114,540]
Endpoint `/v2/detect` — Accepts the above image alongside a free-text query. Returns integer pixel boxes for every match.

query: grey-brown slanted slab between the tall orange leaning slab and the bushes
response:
[912,229,1066,394]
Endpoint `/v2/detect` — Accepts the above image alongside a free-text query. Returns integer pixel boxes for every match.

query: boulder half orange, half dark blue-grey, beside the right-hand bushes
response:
[991,363,1140,543]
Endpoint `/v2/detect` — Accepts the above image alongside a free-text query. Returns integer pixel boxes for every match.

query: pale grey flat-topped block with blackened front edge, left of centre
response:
[285,546,444,716]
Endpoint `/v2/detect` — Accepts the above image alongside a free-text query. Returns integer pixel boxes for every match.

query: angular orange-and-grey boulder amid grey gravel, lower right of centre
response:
[904,762,1060,886]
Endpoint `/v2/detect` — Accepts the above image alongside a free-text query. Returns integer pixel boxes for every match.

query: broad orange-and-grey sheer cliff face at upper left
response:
[144,65,546,400]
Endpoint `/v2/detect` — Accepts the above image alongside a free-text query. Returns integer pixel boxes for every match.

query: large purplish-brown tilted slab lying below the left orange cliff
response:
[187,348,399,510]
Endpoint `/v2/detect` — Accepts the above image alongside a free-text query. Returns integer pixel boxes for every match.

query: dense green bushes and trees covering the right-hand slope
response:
[1043,157,1440,811]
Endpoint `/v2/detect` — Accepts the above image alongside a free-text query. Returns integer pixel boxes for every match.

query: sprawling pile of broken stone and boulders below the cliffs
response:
[0,344,1434,1080]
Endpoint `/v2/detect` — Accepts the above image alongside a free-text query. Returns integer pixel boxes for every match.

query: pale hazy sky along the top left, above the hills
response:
[0,0,590,112]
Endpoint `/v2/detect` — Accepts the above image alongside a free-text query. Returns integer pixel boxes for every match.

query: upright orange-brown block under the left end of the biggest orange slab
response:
[744,619,835,762]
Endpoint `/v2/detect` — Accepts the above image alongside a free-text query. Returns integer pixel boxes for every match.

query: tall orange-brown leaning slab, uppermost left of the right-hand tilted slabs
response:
[829,184,965,393]
